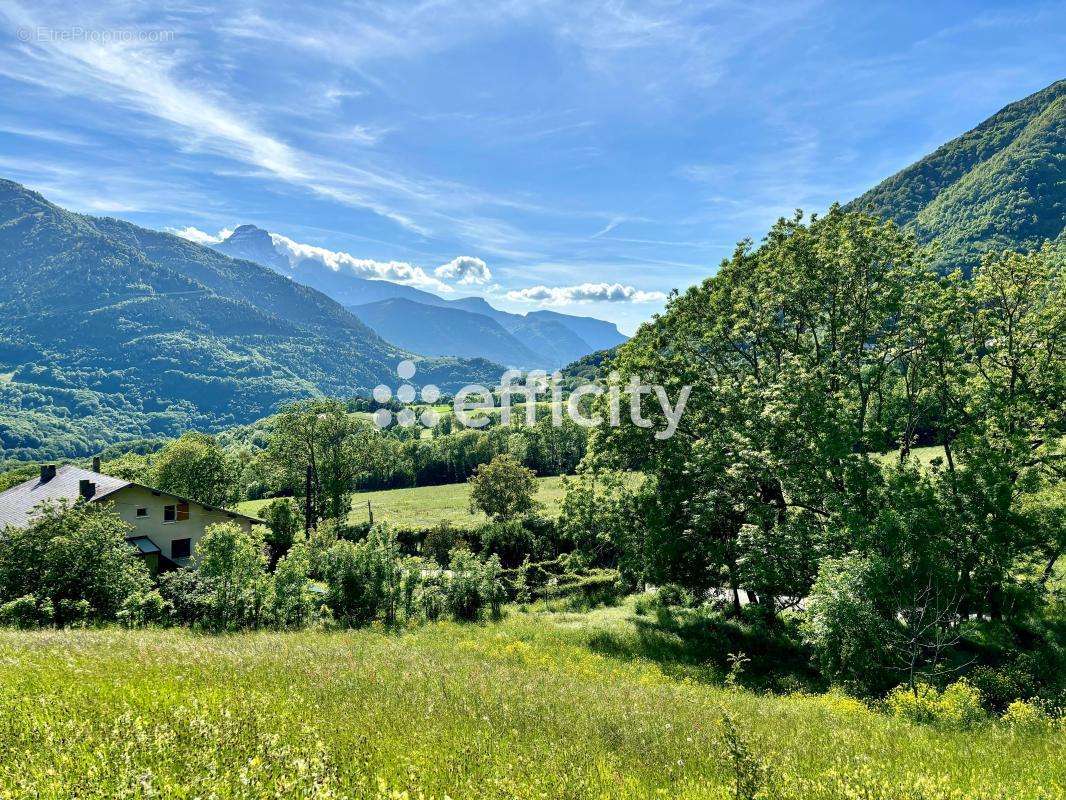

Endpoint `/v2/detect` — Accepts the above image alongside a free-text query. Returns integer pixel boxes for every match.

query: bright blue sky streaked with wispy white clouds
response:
[0,0,1066,332]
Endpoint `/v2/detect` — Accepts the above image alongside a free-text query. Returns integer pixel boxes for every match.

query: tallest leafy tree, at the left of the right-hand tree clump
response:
[597,207,935,605]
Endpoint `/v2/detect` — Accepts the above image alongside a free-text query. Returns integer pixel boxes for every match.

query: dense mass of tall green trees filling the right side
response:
[568,208,1066,700]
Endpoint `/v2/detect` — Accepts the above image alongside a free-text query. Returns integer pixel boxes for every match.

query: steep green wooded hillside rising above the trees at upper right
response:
[850,80,1066,274]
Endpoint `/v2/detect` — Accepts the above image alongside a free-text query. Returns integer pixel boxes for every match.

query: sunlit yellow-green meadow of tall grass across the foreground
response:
[0,610,1066,800]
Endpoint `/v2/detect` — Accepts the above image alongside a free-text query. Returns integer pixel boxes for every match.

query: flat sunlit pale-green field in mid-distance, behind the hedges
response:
[238,478,579,529]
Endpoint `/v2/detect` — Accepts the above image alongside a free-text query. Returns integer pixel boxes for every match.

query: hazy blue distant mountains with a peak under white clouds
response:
[214,225,626,370]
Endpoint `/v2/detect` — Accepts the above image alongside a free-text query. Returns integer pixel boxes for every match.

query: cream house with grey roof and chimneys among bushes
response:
[0,459,262,572]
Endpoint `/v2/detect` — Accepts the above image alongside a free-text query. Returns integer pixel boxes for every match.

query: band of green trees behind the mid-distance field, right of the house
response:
[54,400,588,518]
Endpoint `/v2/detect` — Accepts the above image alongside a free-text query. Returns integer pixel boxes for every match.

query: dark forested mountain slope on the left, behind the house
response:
[0,180,502,457]
